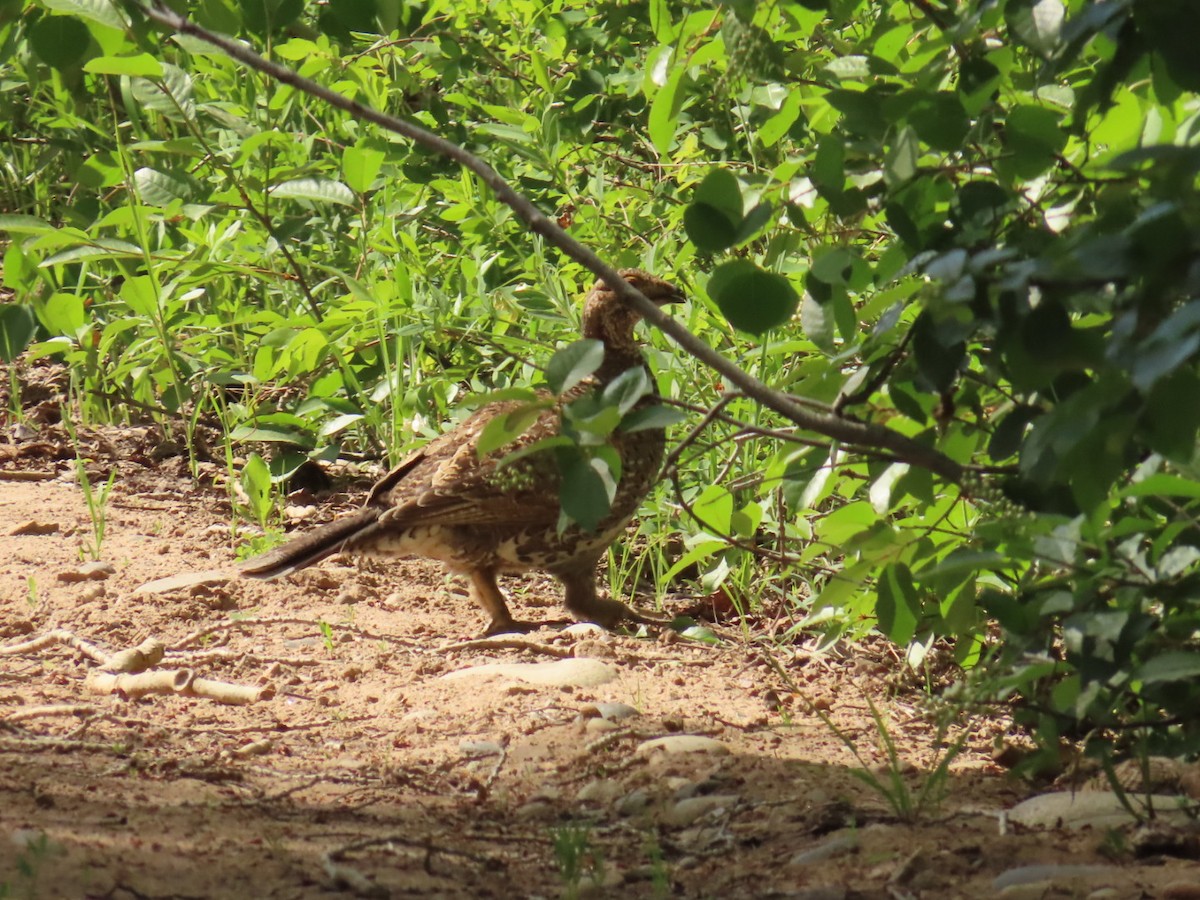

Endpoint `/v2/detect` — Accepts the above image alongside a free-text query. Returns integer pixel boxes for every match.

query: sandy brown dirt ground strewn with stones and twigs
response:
[0,398,1200,900]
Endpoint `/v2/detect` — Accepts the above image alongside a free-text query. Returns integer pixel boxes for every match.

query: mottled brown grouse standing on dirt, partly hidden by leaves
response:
[242,269,683,635]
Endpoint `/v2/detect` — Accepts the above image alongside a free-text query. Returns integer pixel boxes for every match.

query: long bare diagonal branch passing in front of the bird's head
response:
[130,0,970,494]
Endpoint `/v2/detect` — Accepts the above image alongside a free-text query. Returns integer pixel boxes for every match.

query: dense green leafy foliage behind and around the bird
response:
[0,0,1200,751]
